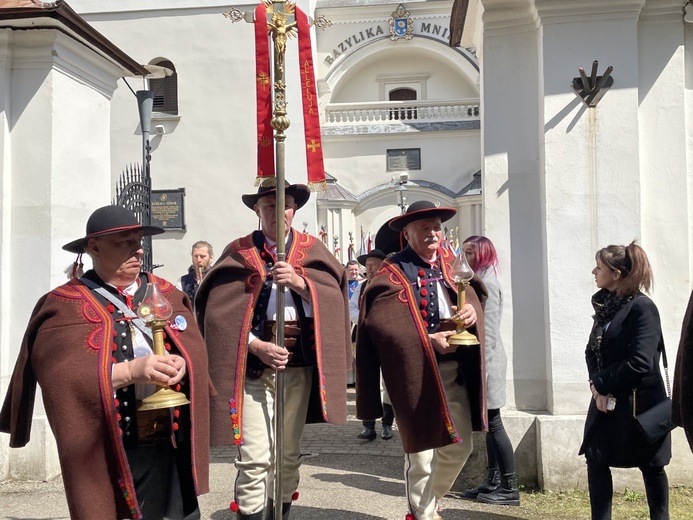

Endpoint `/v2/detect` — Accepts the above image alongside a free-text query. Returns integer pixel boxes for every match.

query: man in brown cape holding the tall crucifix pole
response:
[196,184,351,520]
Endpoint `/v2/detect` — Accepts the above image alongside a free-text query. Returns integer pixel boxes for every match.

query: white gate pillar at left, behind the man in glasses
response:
[0,29,122,480]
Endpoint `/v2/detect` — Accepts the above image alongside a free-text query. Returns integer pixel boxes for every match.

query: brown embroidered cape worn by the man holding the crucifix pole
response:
[195,229,351,445]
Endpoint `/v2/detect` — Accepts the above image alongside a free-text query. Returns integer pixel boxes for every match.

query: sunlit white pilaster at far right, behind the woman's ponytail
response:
[626,0,693,344]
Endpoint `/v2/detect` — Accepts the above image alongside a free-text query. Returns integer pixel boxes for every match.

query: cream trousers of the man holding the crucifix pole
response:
[235,367,314,515]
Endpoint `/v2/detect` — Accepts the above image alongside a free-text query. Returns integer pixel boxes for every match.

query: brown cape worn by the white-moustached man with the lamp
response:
[356,250,488,453]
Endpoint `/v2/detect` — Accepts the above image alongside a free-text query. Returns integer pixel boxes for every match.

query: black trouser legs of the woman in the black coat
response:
[587,462,669,520]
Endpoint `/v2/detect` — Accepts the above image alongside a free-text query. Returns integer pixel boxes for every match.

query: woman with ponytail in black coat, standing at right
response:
[580,243,671,520]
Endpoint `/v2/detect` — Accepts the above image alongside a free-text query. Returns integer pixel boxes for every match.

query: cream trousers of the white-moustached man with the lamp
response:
[404,361,472,520]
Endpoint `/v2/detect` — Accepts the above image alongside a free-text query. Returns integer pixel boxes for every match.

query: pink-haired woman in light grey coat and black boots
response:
[462,235,520,506]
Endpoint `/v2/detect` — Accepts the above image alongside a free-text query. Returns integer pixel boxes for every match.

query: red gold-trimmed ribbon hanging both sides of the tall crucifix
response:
[254,4,327,191]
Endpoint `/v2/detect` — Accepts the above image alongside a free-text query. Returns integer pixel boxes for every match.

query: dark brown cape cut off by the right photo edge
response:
[671,293,693,451]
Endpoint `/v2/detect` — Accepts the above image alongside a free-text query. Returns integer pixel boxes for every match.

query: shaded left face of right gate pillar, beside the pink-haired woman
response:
[479,0,548,410]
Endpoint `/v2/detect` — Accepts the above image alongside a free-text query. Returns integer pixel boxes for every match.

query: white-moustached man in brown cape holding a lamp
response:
[356,201,486,520]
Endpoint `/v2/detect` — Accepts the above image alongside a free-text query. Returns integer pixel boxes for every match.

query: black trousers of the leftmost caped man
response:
[126,436,200,520]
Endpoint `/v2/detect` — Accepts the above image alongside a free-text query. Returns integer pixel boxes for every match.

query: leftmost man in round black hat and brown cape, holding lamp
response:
[0,206,209,520]
